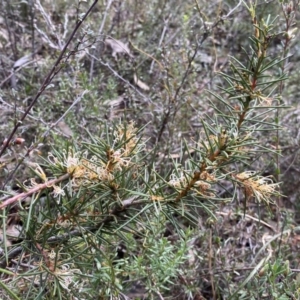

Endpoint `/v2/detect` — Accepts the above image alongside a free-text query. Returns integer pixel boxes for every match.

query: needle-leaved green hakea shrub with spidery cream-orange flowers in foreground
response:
[0,2,298,299]
